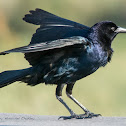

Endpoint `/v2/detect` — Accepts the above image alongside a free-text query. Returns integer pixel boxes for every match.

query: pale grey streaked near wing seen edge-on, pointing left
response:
[0,36,89,55]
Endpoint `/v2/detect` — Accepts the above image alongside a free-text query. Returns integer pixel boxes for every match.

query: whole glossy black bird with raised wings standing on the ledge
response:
[0,9,126,119]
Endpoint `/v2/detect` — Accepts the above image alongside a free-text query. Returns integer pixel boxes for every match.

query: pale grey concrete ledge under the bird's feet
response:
[0,113,126,126]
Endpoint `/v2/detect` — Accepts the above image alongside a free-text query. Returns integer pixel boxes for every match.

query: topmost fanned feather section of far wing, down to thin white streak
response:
[23,9,89,29]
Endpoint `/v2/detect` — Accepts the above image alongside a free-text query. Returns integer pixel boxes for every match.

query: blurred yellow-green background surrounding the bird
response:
[0,0,126,116]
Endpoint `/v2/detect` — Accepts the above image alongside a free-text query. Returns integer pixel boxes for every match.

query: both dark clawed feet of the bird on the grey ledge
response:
[59,112,101,120]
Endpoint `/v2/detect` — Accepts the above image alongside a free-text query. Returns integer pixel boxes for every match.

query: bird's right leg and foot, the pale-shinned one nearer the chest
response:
[66,83,100,119]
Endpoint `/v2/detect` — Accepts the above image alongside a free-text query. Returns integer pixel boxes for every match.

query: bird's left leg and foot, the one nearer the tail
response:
[56,84,75,119]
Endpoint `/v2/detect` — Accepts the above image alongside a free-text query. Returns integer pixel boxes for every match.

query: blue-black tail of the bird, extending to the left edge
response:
[0,67,33,88]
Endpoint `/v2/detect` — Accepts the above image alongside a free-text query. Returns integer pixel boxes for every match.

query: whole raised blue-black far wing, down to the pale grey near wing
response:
[23,9,90,44]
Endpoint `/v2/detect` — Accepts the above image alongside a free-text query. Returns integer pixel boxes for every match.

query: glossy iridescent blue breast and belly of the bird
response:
[44,43,107,84]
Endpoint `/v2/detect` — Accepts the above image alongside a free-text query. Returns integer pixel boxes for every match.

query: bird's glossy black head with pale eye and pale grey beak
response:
[91,21,126,45]
